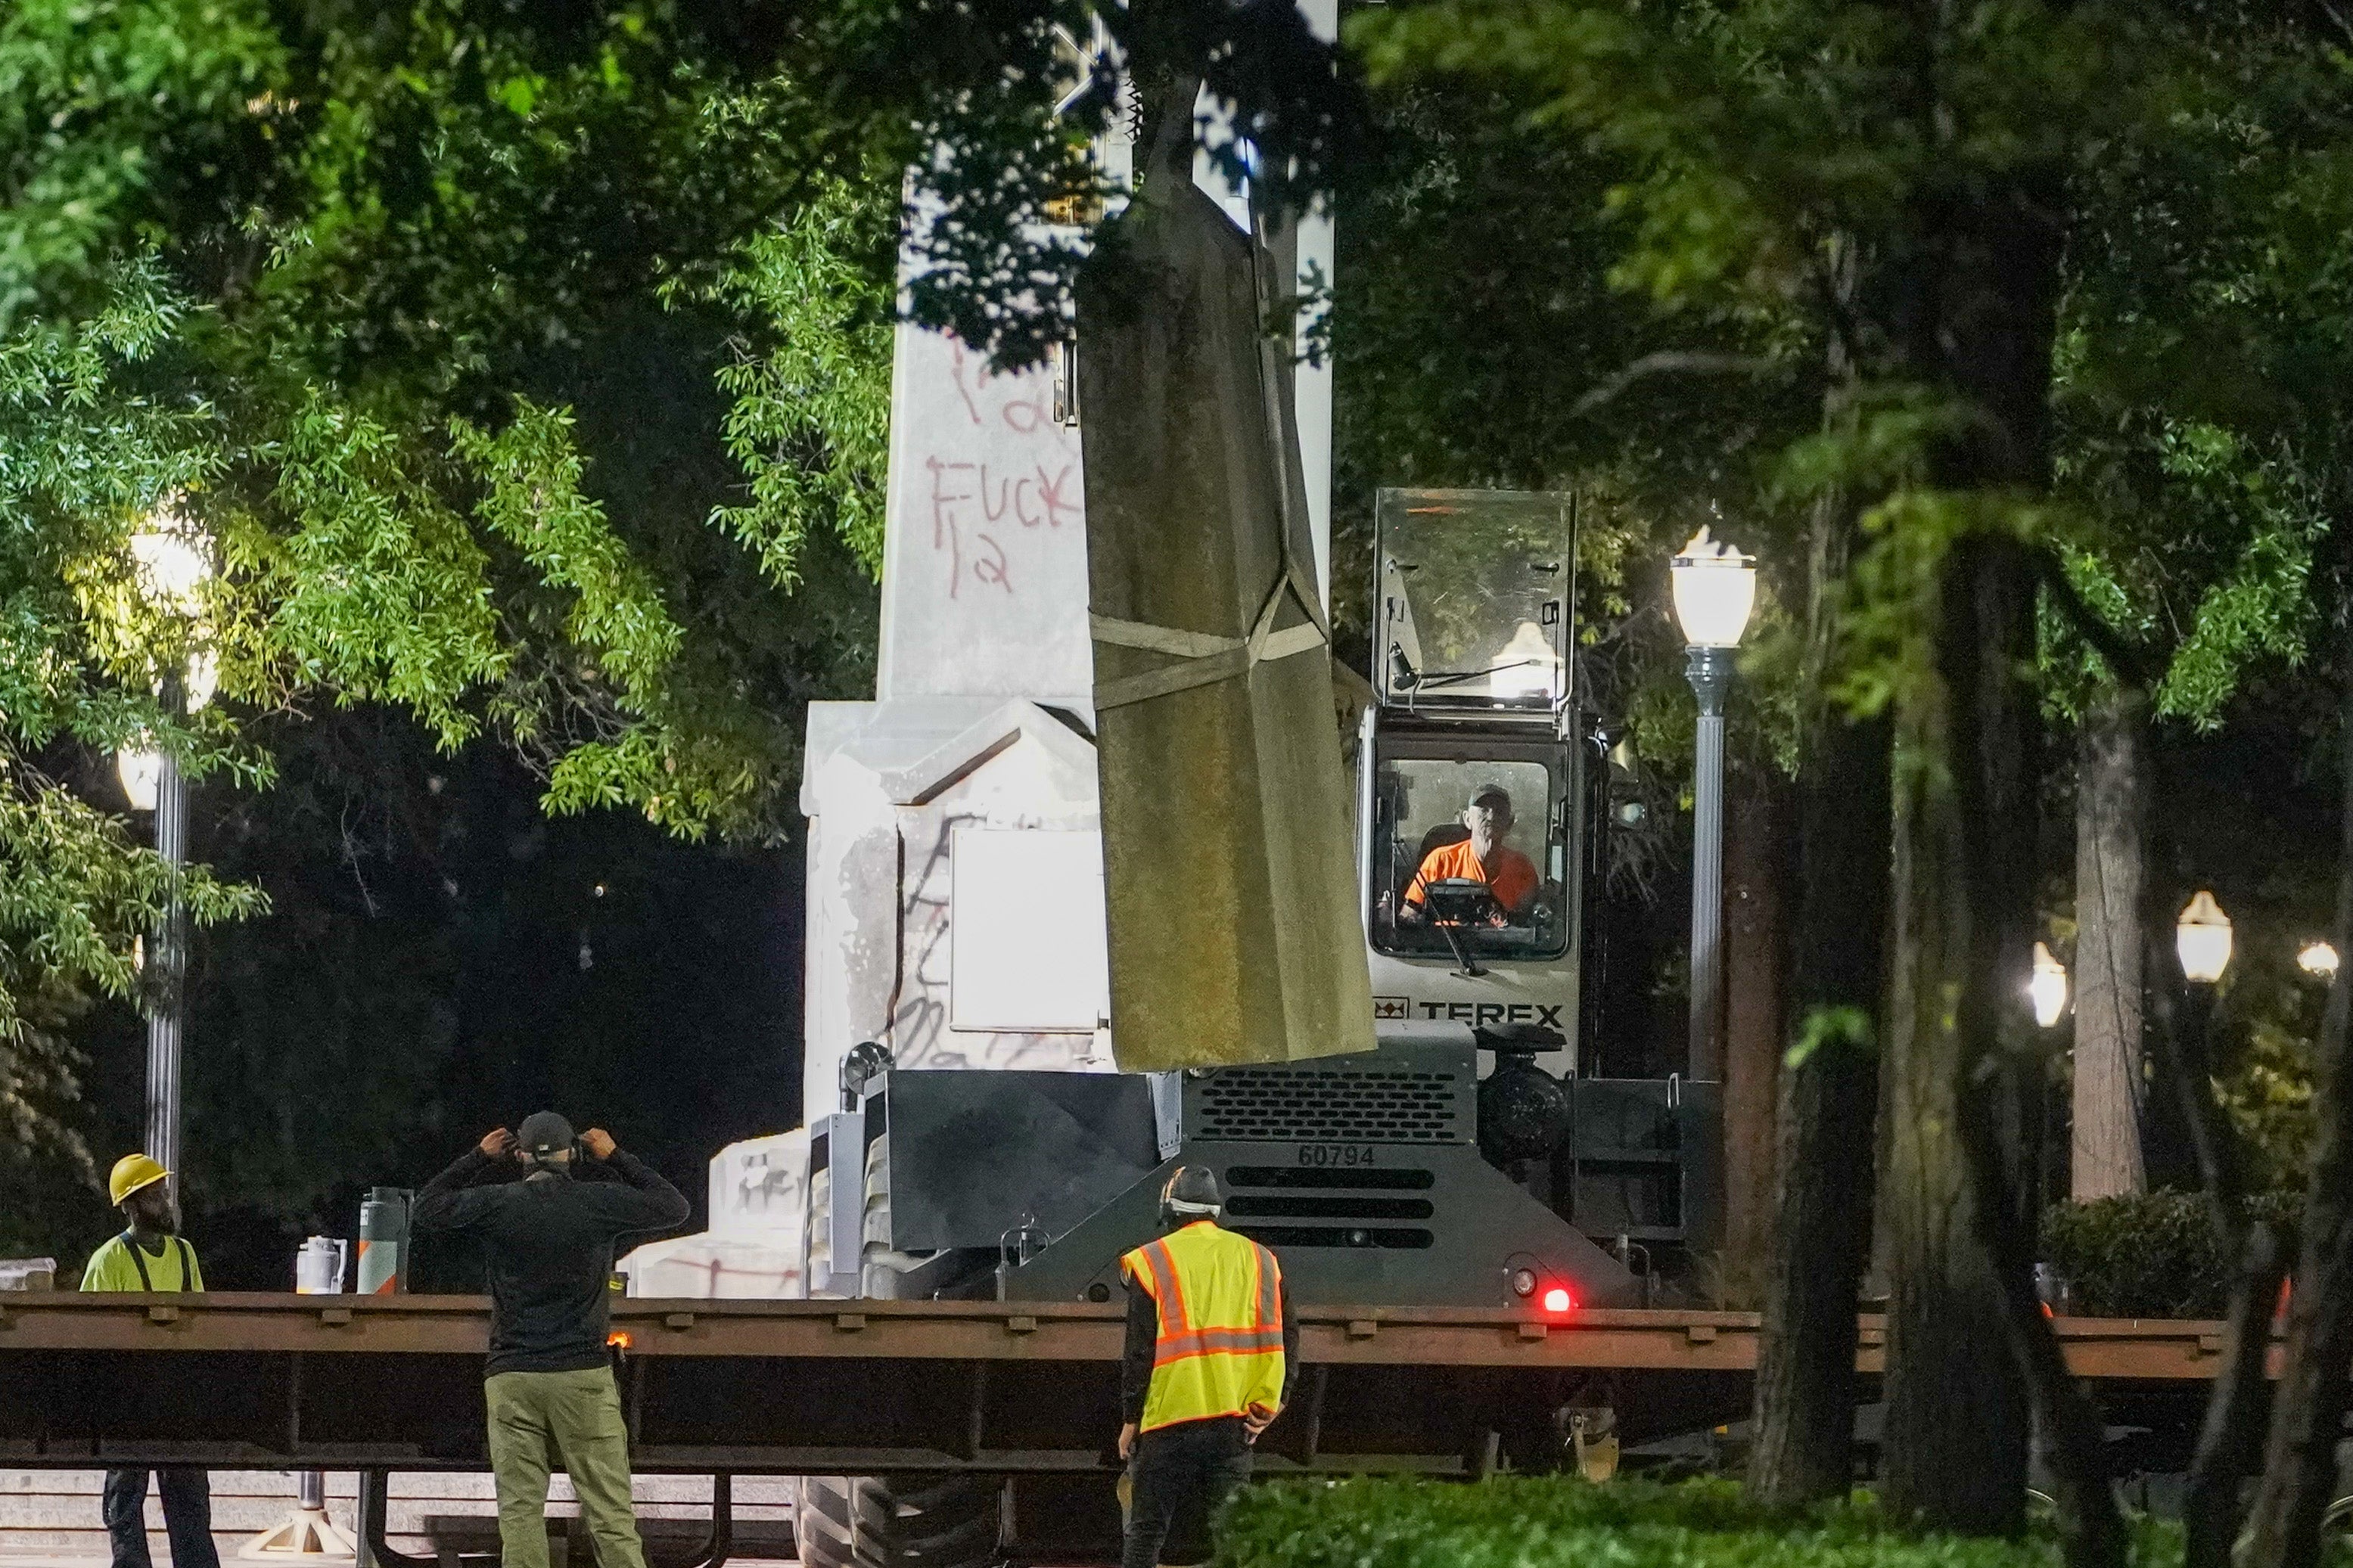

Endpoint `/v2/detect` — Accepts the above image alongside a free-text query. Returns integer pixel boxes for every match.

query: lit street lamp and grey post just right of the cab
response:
[1668,529,1758,1076]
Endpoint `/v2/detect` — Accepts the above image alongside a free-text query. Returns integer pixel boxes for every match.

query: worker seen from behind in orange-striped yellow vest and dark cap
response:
[1120,1166,1299,1568]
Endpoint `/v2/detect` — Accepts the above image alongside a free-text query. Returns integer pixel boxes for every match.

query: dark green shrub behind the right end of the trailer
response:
[2042,1192,2302,1319]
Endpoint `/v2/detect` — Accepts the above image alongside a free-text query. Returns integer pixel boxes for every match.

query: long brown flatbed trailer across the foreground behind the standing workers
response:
[0,1293,2224,1568]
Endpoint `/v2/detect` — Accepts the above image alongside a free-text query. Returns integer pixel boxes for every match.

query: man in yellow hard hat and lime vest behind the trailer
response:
[82,1154,221,1568]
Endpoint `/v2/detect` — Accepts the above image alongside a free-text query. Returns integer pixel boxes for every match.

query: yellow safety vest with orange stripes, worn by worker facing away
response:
[1120,1220,1282,1432]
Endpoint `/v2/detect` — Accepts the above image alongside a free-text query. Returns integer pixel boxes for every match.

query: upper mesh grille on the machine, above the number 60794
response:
[1189,1067,1475,1142]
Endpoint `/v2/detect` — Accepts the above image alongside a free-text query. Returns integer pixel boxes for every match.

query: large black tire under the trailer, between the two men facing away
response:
[793,1476,1005,1568]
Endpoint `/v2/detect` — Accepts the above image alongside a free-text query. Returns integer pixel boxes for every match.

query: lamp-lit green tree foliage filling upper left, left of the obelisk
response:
[0,0,927,1154]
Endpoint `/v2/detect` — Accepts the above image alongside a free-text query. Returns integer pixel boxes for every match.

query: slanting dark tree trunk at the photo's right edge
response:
[2238,618,2353,1568]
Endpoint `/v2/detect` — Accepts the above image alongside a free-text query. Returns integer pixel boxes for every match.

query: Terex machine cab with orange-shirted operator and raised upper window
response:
[1357,489,1586,1053]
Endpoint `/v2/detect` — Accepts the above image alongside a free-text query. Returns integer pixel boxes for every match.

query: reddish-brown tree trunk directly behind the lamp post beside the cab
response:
[1723,762,1791,1305]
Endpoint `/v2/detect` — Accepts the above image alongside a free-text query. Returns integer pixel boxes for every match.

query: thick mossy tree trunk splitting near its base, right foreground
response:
[1882,144,2125,1542]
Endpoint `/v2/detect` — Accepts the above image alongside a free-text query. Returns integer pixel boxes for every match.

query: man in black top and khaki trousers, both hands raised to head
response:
[409,1110,687,1568]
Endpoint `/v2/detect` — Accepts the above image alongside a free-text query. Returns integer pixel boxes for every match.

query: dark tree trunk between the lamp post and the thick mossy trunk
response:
[1748,255,1889,1507]
